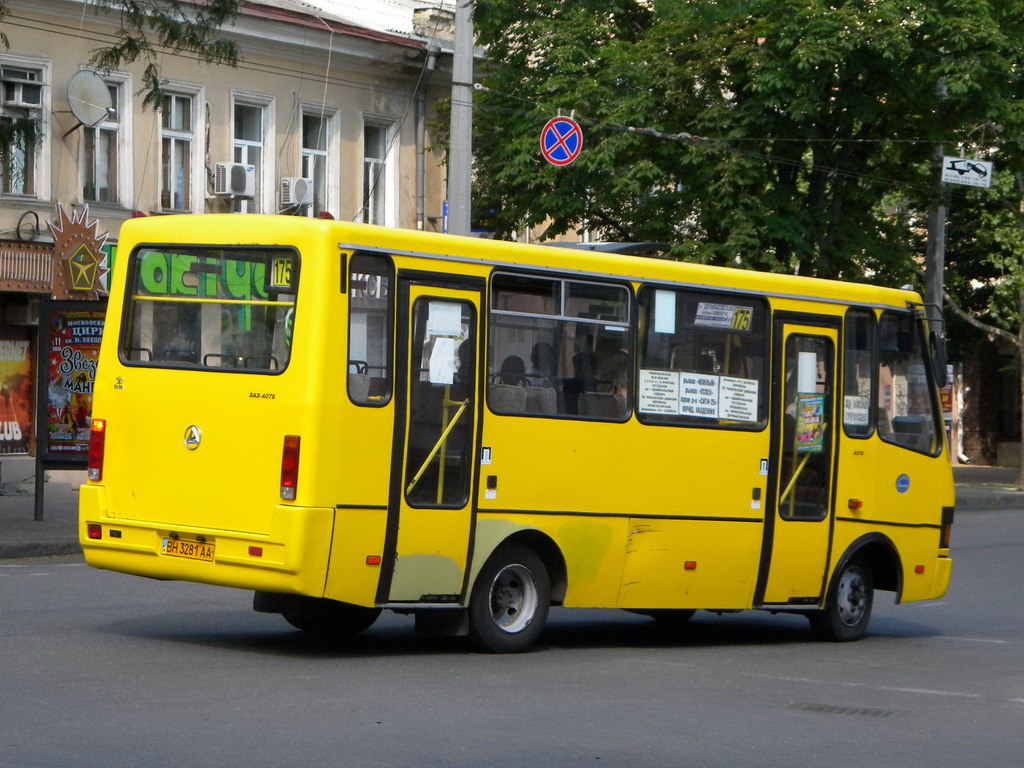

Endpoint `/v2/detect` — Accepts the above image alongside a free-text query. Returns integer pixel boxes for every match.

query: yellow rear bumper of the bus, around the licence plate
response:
[79,484,334,597]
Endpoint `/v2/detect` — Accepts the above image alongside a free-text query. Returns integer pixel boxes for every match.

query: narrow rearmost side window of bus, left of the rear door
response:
[347,253,394,406]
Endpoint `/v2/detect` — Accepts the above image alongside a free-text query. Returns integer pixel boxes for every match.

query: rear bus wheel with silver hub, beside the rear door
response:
[469,547,551,653]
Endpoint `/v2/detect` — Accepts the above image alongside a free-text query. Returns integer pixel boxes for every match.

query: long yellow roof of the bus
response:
[121,213,922,308]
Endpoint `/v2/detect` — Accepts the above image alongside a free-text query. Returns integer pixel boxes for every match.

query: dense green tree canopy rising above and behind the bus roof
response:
[474,0,1024,285]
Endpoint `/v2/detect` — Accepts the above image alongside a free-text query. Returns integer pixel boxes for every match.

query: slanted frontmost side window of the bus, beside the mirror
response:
[878,311,942,456]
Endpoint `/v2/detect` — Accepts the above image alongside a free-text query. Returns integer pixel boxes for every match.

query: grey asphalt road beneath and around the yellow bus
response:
[0,509,1024,768]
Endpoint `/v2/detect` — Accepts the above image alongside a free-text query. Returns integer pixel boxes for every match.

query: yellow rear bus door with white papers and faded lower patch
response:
[378,279,483,603]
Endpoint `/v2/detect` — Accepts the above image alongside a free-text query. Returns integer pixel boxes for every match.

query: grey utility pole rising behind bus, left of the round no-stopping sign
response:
[447,0,473,234]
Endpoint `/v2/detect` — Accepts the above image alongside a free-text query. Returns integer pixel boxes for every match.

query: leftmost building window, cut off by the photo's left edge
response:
[0,65,46,196]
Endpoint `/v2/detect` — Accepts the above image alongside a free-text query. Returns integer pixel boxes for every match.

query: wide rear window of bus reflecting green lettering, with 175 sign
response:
[121,246,299,373]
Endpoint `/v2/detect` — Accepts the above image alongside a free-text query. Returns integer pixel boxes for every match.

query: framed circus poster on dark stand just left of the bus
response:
[40,302,106,464]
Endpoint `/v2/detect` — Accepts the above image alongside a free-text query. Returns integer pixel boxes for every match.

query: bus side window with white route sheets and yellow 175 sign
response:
[637,286,768,429]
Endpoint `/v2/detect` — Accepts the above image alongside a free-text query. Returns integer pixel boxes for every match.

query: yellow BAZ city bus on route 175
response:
[80,215,953,651]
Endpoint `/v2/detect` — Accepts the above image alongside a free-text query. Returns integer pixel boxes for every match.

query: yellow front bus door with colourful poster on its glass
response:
[758,319,839,605]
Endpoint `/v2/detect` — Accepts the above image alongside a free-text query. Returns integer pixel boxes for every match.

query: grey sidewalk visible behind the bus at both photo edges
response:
[0,457,1024,560]
